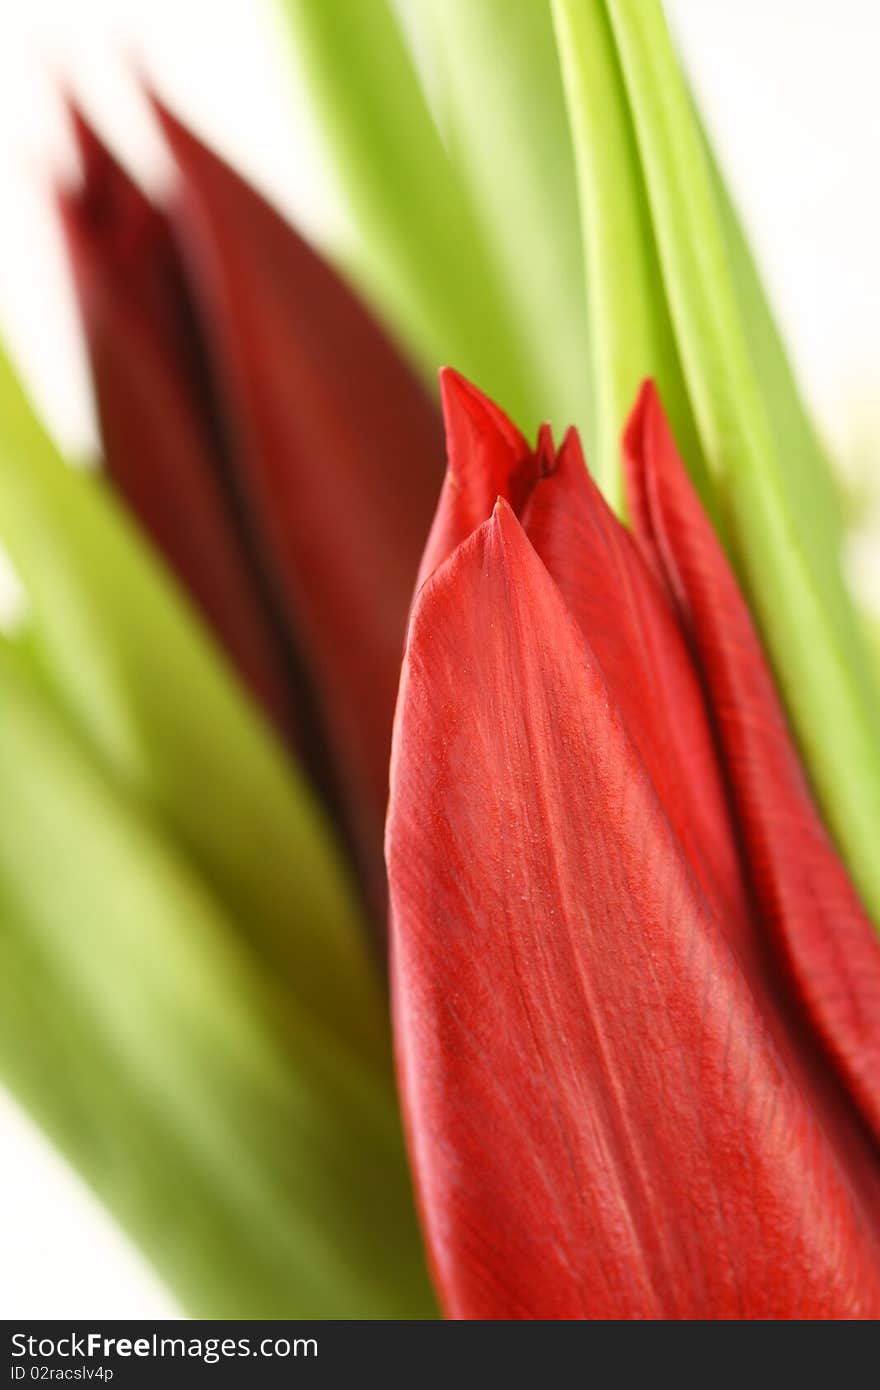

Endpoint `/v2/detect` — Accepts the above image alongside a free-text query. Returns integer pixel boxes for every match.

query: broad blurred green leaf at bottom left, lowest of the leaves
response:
[0,655,432,1318]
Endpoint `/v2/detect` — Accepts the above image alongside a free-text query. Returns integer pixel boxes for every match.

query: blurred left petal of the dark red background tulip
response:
[58,107,293,750]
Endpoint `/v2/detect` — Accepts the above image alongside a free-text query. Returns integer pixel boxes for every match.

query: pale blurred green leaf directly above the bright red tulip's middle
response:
[396,0,592,441]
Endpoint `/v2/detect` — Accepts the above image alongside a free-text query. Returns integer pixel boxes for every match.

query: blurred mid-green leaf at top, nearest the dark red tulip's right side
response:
[276,0,542,428]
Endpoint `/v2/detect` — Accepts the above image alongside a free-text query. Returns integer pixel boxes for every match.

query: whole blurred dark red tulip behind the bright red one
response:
[60,106,443,910]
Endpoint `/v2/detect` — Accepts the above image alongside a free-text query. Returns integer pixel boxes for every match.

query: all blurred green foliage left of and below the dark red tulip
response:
[0,344,432,1318]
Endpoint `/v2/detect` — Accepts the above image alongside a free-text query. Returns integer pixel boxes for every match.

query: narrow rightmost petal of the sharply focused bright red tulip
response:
[626,384,880,1138]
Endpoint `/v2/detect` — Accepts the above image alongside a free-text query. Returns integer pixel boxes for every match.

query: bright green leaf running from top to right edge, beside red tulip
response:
[608,0,880,922]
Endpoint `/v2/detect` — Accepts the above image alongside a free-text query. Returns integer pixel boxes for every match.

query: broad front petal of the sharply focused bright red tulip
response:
[386,503,880,1319]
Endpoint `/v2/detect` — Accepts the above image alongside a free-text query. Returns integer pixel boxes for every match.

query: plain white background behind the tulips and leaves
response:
[0,0,880,1318]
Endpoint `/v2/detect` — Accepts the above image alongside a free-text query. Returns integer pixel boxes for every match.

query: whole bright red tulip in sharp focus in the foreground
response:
[386,374,880,1319]
